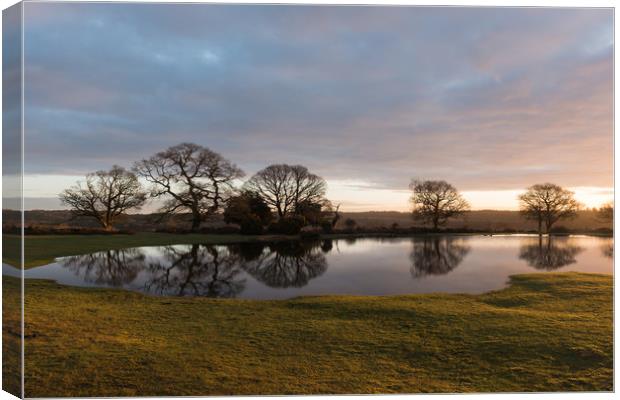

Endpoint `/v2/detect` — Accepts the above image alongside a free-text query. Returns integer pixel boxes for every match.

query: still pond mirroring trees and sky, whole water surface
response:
[3,235,613,299]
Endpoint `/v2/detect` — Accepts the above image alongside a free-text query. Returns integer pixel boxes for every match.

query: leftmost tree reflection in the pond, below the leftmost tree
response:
[62,249,144,287]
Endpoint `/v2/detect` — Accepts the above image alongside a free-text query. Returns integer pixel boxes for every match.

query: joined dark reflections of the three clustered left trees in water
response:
[61,240,333,297]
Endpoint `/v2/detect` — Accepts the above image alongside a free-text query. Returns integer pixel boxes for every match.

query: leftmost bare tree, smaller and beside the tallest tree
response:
[59,165,147,230]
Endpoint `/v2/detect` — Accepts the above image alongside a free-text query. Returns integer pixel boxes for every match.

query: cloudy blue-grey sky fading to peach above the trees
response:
[12,3,613,211]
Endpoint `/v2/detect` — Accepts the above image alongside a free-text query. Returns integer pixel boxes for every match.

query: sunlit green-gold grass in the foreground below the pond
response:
[3,272,613,397]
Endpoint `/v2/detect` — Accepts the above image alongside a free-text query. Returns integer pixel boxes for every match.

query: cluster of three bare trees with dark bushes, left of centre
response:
[59,143,339,233]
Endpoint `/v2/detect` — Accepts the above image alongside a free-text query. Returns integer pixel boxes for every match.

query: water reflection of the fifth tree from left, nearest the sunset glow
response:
[519,236,583,271]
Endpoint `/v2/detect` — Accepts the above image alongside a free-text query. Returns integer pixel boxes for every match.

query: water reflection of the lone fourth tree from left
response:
[410,236,471,278]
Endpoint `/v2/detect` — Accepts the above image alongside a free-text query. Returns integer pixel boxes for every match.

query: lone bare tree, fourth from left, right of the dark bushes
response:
[409,180,469,230]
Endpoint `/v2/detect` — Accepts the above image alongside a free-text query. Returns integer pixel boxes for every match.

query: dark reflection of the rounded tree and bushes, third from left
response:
[237,241,331,288]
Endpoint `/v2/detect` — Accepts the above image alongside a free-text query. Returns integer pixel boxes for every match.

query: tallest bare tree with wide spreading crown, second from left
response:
[134,143,244,231]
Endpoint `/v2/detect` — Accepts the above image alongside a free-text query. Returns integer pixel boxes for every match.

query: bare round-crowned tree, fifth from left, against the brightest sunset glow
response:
[519,183,581,234]
